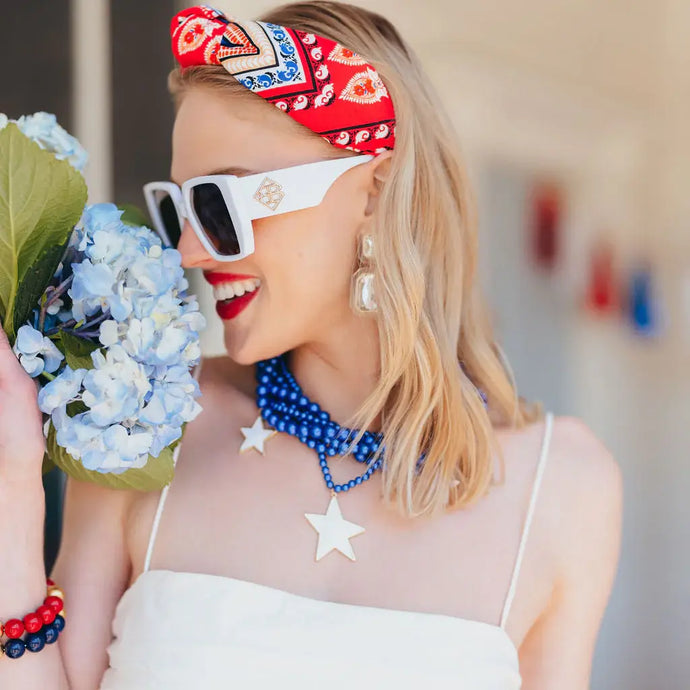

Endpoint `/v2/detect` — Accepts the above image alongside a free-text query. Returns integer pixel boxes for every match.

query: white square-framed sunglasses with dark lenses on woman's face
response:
[144,154,374,261]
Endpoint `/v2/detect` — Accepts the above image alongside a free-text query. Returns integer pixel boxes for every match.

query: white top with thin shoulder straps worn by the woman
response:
[100,413,552,690]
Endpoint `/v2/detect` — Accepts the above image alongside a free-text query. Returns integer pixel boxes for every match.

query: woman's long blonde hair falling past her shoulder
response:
[168,0,543,517]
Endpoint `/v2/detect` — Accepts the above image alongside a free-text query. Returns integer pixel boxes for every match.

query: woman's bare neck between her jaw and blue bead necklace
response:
[289,317,379,431]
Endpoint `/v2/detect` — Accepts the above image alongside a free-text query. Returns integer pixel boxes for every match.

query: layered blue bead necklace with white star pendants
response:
[240,355,383,561]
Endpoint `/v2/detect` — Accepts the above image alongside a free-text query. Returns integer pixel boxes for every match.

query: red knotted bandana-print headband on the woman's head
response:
[170,5,395,153]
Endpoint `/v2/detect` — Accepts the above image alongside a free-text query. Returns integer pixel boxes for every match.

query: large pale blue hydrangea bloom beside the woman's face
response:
[35,204,205,473]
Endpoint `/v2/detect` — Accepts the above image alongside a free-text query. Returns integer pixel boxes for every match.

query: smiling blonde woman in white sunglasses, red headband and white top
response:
[0,2,622,690]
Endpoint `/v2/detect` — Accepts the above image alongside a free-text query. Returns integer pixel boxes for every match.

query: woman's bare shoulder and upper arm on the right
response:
[519,417,623,690]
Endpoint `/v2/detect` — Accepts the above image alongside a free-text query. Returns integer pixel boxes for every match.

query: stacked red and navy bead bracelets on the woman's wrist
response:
[0,578,65,658]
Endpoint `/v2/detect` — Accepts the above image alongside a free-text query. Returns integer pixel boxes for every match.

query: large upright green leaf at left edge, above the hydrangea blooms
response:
[0,122,86,340]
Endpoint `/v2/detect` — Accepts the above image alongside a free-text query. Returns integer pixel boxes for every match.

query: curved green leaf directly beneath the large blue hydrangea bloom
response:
[46,423,174,491]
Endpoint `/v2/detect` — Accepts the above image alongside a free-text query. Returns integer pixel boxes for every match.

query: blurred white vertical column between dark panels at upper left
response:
[71,0,113,203]
